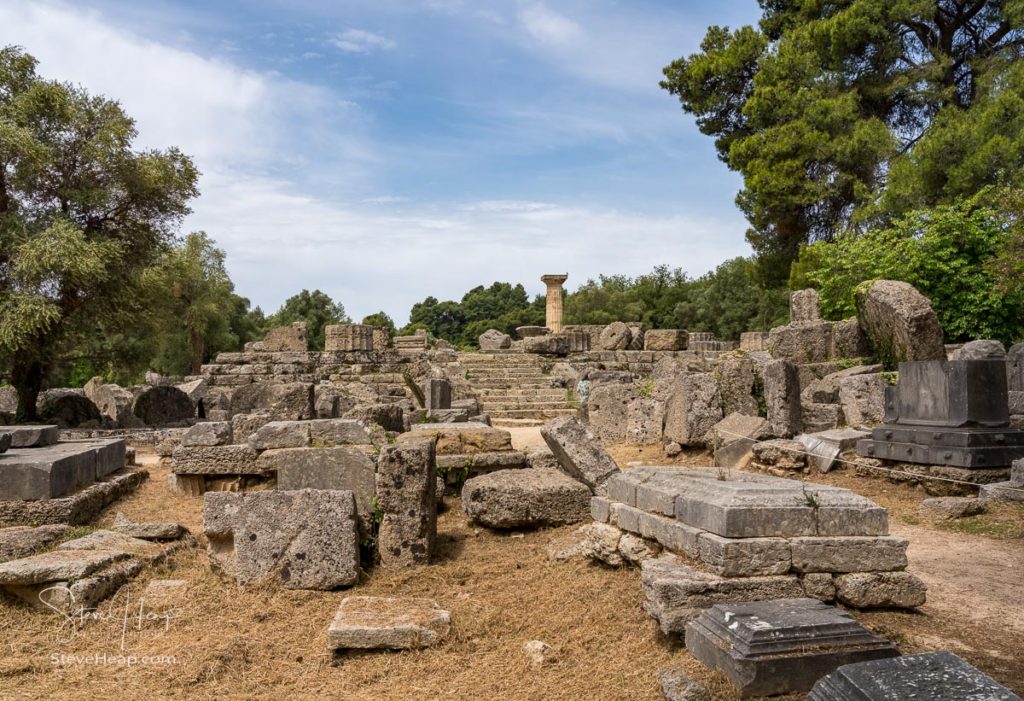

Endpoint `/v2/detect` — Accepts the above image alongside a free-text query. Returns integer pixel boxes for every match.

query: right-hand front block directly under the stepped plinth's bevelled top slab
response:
[790,535,907,573]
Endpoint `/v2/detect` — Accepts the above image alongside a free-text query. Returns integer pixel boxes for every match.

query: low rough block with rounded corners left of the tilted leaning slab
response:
[462,470,591,528]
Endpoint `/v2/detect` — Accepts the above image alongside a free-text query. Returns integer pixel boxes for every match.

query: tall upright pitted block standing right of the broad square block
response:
[376,436,438,567]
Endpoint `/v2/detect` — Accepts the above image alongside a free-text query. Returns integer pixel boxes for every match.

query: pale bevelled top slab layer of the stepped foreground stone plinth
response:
[667,468,889,538]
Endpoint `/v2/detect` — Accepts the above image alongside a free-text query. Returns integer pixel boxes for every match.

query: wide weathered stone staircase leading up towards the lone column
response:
[459,351,575,423]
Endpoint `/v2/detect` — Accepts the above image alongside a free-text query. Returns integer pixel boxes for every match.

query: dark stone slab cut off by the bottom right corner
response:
[807,652,1021,701]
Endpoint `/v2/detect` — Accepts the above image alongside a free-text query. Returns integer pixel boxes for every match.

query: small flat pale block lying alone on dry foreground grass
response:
[327,597,452,650]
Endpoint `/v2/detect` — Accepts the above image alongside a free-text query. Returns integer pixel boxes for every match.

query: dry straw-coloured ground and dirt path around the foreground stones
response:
[0,440,1024,701]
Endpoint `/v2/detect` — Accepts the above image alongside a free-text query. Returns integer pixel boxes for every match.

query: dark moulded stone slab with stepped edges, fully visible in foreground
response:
[686,599,899,697]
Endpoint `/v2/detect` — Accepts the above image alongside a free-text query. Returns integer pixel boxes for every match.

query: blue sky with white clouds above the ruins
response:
[0,0,759,324]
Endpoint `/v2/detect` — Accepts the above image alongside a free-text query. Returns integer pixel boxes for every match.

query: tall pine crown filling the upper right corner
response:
[662,0,1024,281]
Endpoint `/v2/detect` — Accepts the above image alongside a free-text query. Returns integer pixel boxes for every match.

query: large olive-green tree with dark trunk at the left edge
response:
[0,47,198,421]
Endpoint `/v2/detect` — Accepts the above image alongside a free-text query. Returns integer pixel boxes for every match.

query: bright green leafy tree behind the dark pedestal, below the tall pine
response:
[793,192,1024,343]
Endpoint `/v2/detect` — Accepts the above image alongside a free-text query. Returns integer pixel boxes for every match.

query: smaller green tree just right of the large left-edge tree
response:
[145,231,240,375]
